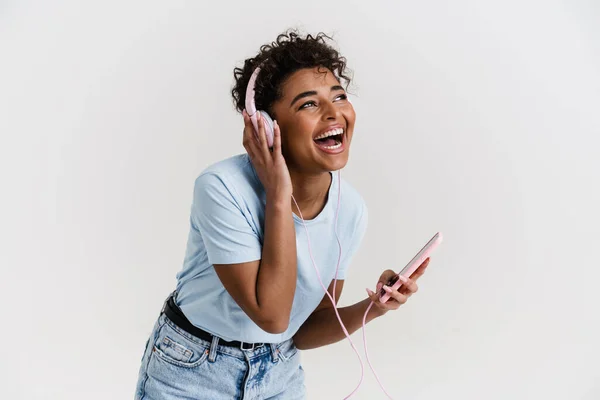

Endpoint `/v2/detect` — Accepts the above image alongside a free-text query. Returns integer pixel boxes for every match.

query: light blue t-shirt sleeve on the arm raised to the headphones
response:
[191,173,262,265]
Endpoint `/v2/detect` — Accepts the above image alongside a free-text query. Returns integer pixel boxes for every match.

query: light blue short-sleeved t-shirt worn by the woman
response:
[177,154,368,343]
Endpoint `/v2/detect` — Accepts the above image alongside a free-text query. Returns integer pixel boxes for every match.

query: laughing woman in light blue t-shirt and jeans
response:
[136,31,428,400]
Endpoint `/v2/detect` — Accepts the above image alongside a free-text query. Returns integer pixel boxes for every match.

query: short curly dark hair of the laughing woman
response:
[231,29,351,116]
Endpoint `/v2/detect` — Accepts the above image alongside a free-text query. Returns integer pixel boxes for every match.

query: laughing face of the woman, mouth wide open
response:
[272,67,356,174]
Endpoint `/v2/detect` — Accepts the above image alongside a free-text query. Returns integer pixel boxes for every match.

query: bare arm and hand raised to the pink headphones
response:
[214,112,297,333]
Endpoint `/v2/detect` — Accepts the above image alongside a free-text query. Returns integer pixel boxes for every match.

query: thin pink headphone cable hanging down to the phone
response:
[292,170,392,400]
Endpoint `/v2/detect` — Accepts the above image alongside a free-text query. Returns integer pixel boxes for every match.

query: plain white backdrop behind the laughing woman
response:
[0,0,600,400]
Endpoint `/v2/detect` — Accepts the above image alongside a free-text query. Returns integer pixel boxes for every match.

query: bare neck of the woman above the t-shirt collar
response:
[290,170,333,220]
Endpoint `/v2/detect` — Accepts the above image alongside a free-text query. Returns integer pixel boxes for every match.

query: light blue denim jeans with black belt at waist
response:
[135,314,306,400]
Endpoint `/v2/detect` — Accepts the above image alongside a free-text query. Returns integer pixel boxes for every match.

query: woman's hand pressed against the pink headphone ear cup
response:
[242,110,292,200]
